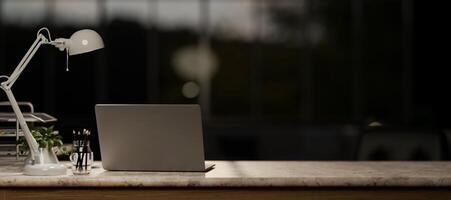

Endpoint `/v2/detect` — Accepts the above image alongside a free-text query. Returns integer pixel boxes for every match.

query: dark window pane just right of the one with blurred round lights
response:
[208,0,259,116]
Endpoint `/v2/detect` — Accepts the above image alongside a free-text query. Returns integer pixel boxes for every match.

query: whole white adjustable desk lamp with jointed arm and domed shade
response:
[0,28,104,175]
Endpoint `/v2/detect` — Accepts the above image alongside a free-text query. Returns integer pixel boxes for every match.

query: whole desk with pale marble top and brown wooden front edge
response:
[0,161,451,200]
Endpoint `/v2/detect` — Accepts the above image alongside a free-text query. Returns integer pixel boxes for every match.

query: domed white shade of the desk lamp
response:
[68,29,104,56]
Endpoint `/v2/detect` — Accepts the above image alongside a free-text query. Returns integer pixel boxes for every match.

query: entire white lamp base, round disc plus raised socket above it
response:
[23,148,67,176]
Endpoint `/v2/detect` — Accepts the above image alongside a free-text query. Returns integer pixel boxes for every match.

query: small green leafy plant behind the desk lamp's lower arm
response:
[17,126,63,153]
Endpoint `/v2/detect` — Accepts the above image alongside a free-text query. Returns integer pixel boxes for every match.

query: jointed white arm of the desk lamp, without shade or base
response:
[0,34,47,160]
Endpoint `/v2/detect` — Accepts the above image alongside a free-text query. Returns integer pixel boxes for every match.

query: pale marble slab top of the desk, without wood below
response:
[0,160,451,187]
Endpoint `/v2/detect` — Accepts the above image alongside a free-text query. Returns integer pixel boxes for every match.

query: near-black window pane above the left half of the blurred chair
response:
[363,0,404,122]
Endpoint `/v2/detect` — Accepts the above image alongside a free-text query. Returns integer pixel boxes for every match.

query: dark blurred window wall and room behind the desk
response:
[0,0,451,160]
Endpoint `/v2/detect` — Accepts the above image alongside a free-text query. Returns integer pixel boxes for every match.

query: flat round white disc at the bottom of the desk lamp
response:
[23,163,67,176]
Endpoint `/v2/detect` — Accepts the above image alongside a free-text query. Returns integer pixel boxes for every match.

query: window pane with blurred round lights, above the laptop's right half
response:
[157,0,201,103]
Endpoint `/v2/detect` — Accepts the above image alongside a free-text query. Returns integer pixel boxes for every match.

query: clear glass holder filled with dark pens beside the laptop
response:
[70,140,94,175]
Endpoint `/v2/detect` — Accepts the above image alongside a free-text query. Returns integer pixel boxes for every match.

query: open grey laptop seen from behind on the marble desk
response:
[95,104,213,171]
